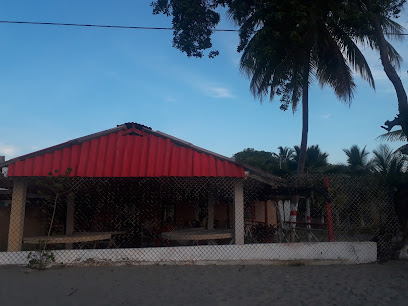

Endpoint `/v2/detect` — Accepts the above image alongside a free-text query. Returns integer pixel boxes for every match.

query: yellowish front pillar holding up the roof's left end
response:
[7,179,27,252]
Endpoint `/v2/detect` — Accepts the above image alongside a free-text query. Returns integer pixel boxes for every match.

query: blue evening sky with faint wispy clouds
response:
[0,0,408,163]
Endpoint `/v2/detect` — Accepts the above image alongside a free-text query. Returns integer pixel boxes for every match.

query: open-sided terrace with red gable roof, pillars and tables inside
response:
[0,123,281,252]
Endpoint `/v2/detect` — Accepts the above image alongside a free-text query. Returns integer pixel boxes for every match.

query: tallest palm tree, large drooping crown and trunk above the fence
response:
[233,0,374,175]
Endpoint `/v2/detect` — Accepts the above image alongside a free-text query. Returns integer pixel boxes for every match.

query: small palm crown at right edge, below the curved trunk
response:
[371,144,407,176]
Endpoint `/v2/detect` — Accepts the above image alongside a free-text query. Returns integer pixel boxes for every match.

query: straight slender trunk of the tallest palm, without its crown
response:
[290,50,310,242]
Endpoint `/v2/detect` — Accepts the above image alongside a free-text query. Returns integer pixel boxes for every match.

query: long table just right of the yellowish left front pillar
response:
[23,231,126,249]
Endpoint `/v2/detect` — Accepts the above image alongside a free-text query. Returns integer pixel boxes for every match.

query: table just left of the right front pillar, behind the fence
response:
[161,228,234,245]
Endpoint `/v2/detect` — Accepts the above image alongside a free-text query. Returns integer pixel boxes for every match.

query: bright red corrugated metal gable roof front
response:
[6,124,245,177]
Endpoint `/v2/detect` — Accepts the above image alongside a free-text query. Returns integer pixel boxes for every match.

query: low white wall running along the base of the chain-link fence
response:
[0,242,377,265]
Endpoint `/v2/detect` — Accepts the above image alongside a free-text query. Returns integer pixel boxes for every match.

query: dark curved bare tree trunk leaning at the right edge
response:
[373,17,408,137]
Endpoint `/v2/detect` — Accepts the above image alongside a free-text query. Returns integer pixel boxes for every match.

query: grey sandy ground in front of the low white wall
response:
[0,261,408,306]
